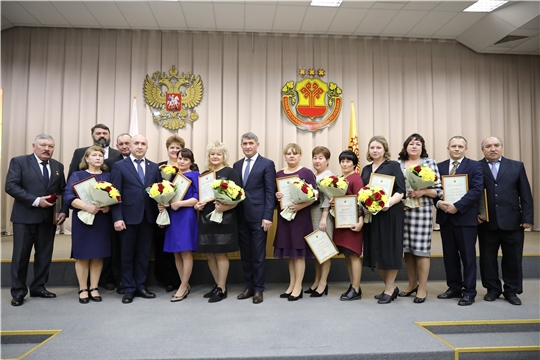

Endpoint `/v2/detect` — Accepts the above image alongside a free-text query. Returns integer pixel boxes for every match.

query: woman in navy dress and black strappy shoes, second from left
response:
[64,146,112,304]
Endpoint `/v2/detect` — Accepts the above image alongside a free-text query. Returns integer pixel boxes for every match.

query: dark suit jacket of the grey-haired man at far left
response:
[5,153,69,224]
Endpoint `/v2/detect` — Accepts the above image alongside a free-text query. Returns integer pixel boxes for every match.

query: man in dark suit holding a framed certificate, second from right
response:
[434,136,484,306]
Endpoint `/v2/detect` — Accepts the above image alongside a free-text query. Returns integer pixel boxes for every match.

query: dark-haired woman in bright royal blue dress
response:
[163,148,199,302]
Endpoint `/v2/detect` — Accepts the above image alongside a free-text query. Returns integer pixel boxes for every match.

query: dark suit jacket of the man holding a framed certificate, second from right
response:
[433,158,484,226]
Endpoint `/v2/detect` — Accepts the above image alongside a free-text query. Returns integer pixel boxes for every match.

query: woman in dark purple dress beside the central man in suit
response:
[274,143,317,301]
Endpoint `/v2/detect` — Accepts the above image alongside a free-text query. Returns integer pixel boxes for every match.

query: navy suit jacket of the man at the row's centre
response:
[233,154,276,222]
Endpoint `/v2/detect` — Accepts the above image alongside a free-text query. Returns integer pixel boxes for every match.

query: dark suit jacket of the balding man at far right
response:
[480,157,534,231]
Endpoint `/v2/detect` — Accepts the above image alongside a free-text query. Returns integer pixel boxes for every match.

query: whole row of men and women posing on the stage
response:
[5,124,533,306]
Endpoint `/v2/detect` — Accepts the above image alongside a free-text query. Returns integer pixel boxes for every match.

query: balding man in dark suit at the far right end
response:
[478,137,534,305]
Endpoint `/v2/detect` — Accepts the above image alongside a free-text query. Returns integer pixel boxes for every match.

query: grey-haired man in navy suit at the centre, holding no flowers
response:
[233,132,276,304]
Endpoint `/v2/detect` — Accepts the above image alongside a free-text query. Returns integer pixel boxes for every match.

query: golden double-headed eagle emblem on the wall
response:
[144,65,203,130]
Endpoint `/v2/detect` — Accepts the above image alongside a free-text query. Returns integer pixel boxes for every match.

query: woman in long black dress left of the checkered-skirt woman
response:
[362,136,405,304]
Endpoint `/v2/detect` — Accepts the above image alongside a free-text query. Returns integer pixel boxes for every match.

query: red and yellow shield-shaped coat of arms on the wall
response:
[281,69,342,131]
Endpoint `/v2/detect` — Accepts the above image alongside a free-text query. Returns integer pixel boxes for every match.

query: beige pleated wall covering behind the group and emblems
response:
[1,28,540,230]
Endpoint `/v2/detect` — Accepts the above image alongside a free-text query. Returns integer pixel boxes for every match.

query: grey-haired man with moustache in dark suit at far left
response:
[5,134,68,306]
